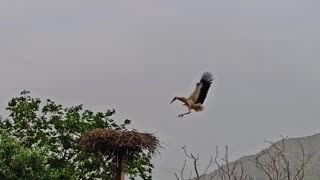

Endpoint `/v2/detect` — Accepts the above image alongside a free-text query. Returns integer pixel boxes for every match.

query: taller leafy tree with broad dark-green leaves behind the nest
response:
[0,91,153,179]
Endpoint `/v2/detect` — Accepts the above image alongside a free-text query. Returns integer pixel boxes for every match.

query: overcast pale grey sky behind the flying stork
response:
[0,0,320,180]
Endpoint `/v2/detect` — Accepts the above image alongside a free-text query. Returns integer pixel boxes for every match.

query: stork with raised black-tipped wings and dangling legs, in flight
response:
[170,72,213,118]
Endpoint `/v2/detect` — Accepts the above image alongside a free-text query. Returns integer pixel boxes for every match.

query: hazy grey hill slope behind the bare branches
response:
[193,133,320,180]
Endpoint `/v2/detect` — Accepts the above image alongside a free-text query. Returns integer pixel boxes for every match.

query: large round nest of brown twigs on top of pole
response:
[80,129,160,159]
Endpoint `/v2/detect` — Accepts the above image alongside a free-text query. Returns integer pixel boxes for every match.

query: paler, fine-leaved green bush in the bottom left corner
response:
[0,131,59,180]
